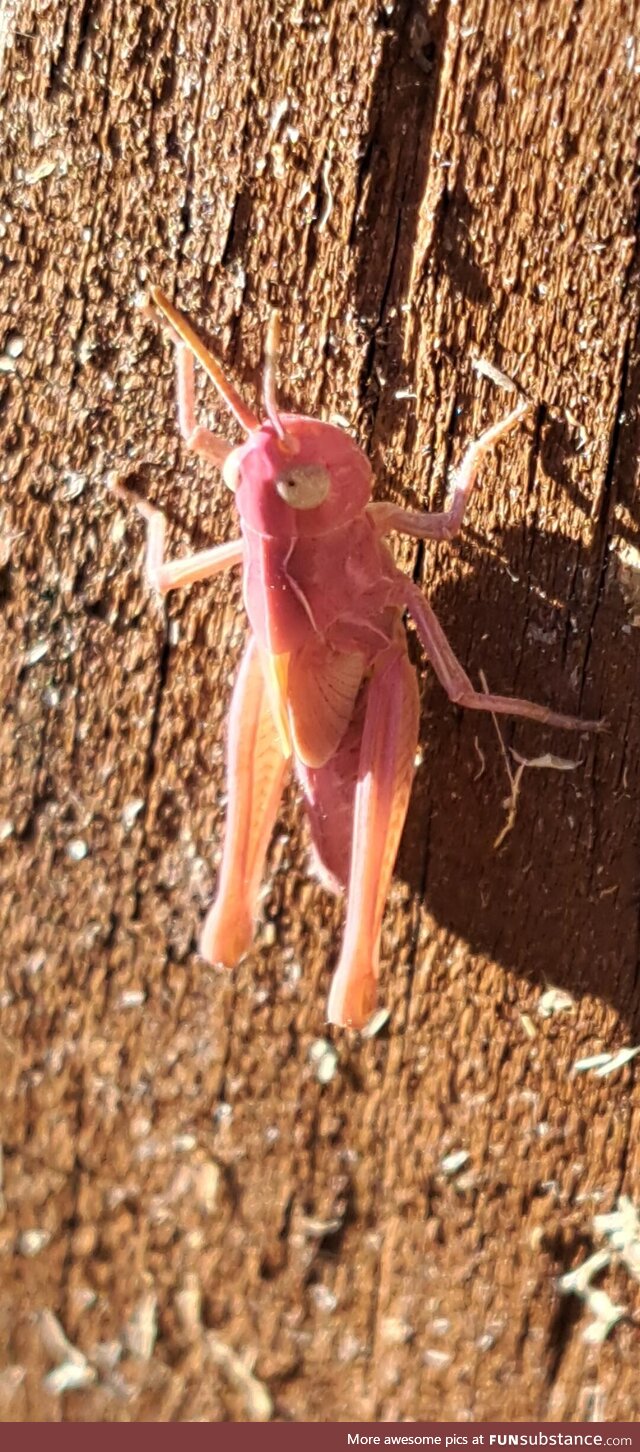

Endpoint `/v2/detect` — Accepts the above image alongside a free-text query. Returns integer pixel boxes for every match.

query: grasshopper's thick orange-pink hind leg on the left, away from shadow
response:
[200,639,289,968]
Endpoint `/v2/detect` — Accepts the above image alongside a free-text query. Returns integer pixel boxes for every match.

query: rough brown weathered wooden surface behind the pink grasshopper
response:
[0,0,640,1420]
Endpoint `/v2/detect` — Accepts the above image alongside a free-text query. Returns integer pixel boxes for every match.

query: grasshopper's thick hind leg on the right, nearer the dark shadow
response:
[328,645,419,1028]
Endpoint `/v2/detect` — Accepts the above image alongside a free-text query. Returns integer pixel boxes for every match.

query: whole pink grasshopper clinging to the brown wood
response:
[119,289,598,1028]
